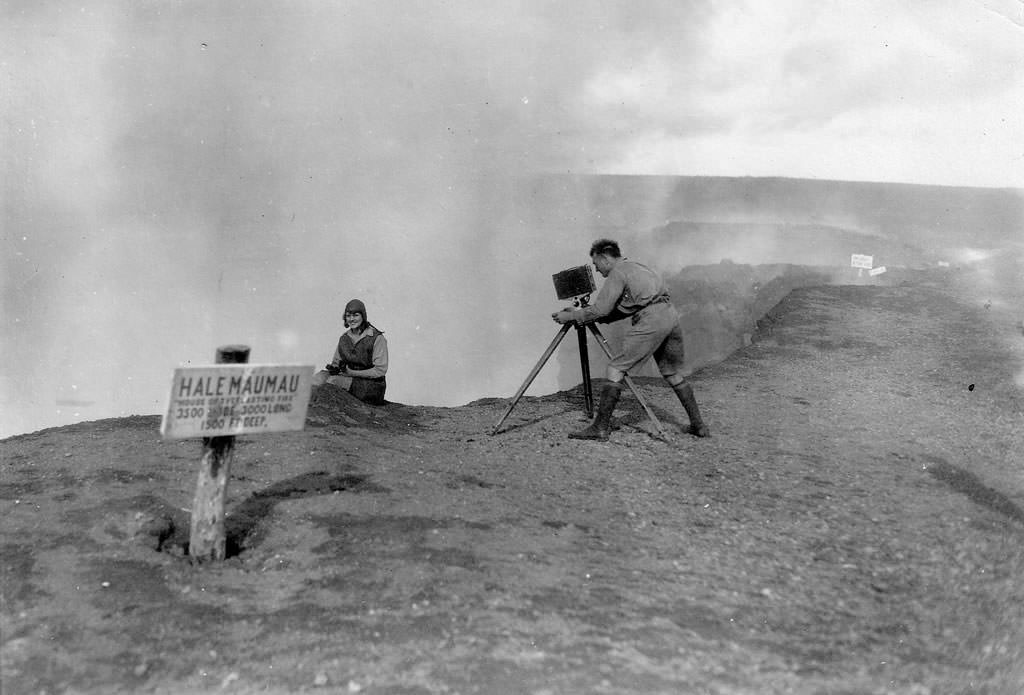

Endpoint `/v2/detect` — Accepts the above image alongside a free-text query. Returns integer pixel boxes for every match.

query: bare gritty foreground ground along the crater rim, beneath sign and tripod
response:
[0,270,1024,695]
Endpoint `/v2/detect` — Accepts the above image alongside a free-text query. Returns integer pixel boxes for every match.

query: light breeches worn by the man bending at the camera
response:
[607,303,683,382]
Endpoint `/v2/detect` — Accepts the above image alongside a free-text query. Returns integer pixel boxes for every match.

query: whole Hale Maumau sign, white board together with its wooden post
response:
[160,345,313,563]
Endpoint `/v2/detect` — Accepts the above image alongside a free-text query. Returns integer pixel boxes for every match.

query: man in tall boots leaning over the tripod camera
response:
[551,238,710,441]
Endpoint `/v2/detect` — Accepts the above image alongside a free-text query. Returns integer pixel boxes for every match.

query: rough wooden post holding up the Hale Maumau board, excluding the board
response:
[188,345,249,563]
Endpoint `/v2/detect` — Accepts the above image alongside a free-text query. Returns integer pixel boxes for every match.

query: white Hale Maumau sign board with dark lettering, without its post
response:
[160,364,313,439]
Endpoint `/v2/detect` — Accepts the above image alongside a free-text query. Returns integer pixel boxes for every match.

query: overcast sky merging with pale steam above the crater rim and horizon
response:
[0,0,1024,436]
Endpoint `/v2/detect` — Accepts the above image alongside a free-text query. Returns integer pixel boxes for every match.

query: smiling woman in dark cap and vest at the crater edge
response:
[313,299,387,405]
